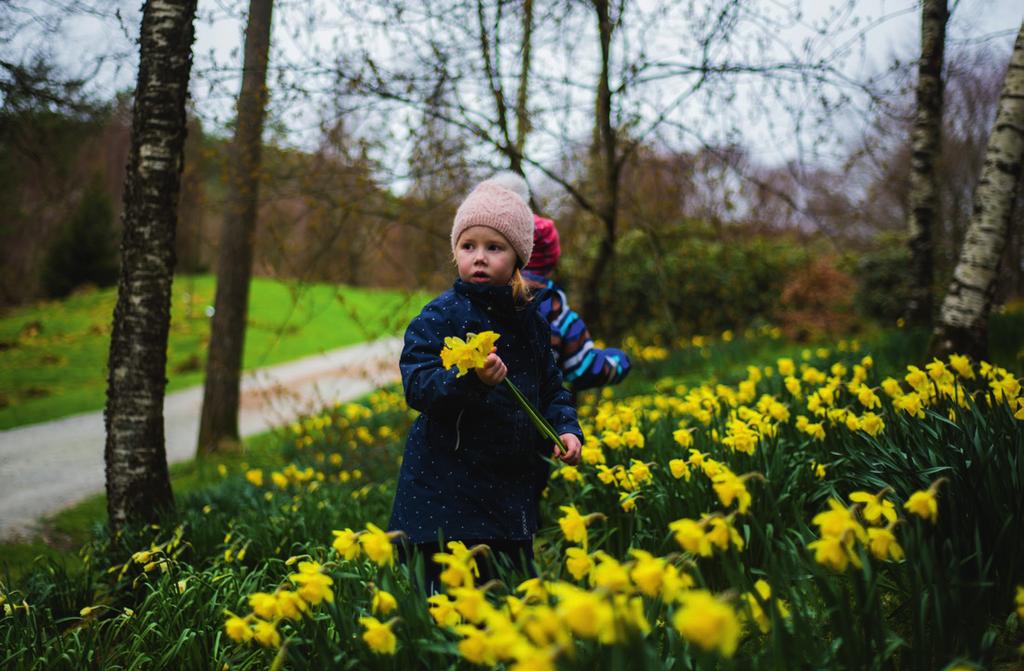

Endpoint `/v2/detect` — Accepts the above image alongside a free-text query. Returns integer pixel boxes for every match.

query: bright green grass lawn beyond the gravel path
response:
[0,276,428,429]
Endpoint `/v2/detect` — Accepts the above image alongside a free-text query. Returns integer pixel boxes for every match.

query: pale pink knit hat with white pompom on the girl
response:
[452,179,534,265]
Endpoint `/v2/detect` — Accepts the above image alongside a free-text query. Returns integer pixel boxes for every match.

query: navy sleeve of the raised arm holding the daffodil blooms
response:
[398,305,492,413]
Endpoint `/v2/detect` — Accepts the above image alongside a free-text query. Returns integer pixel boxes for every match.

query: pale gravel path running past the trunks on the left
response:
[0,338,401,540]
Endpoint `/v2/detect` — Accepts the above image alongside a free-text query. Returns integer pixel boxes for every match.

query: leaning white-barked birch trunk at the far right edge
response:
[931,24,1024,359]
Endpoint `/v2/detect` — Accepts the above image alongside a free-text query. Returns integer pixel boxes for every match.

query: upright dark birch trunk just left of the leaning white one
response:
[906,0,949,326]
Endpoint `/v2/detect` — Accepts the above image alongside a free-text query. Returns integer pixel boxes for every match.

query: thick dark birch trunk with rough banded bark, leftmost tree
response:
[103,0,197,530]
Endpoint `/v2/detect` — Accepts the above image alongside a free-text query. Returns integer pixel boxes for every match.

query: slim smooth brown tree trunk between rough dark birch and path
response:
[197,0,273,456]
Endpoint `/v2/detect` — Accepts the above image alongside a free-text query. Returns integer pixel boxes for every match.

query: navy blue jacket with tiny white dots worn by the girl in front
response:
[388,280,583,543]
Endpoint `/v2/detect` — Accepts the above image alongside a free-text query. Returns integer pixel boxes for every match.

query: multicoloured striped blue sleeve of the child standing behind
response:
[540,289,631,391]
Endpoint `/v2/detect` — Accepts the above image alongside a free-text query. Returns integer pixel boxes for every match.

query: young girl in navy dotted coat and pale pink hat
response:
[388,180,583,592]
